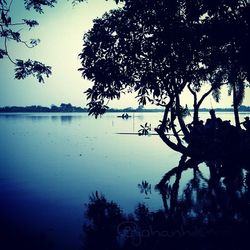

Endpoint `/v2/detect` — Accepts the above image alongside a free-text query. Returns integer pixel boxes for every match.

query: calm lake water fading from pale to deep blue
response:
[0,113,249,250]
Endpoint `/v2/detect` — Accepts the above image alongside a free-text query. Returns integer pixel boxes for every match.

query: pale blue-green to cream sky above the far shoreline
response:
[0,0,250,107]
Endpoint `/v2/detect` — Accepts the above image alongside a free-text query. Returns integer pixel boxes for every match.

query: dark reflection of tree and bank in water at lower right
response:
[83,156,250,250]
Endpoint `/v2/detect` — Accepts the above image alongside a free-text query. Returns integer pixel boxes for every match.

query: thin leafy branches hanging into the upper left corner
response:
[0,0,85,82]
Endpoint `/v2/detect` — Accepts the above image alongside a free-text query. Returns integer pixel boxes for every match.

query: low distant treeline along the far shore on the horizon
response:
[0,103,250,113]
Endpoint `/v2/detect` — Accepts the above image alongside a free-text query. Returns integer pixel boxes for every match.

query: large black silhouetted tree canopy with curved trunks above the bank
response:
[80,0,249,156]
